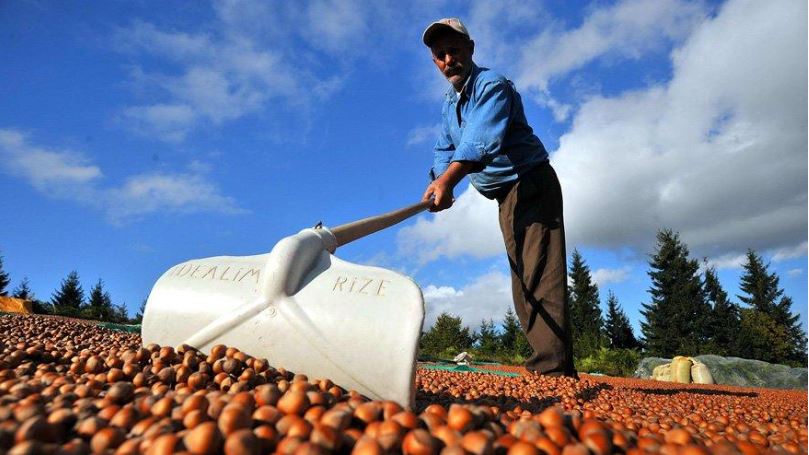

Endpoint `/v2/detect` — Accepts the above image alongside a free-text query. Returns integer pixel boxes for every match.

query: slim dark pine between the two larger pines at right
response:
[704,261,739,355]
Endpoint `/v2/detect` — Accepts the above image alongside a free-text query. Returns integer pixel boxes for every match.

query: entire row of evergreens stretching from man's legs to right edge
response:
[544,229,806,365]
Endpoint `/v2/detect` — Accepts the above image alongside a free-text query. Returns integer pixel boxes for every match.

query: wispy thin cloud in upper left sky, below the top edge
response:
[116,22,296,142]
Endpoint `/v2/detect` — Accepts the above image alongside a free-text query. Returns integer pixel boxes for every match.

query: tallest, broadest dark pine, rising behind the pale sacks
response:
[641,229,710,357]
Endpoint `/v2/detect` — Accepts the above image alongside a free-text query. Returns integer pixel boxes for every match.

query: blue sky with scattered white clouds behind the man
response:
[0,0,807,338]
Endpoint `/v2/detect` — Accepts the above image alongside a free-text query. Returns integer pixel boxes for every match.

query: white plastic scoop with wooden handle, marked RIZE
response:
[141,201,432,408]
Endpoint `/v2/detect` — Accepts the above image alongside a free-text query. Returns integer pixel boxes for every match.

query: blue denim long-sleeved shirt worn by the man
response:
[430,64,548,199]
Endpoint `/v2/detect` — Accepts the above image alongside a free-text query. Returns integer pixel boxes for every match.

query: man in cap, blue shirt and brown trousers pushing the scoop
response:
[422,18,576,377]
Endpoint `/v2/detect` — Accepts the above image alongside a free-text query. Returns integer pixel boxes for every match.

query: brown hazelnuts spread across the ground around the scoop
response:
[0,315,807,455]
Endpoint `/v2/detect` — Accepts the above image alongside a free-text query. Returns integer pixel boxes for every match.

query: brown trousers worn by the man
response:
[497,163,577,377]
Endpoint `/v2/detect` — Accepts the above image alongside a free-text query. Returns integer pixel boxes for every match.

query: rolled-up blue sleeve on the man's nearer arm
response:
[451,81,511,171]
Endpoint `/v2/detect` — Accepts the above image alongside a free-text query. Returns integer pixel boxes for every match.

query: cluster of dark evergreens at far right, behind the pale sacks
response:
[641,229,806,366]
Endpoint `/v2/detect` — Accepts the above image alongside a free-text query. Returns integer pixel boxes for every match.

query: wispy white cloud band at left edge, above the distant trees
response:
[0,129,244,223]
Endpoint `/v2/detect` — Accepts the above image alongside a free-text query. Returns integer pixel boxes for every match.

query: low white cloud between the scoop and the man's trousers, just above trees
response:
[424,271,514,330]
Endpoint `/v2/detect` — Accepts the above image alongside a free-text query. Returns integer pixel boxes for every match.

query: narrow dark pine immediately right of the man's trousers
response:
[570,250,604,358]
